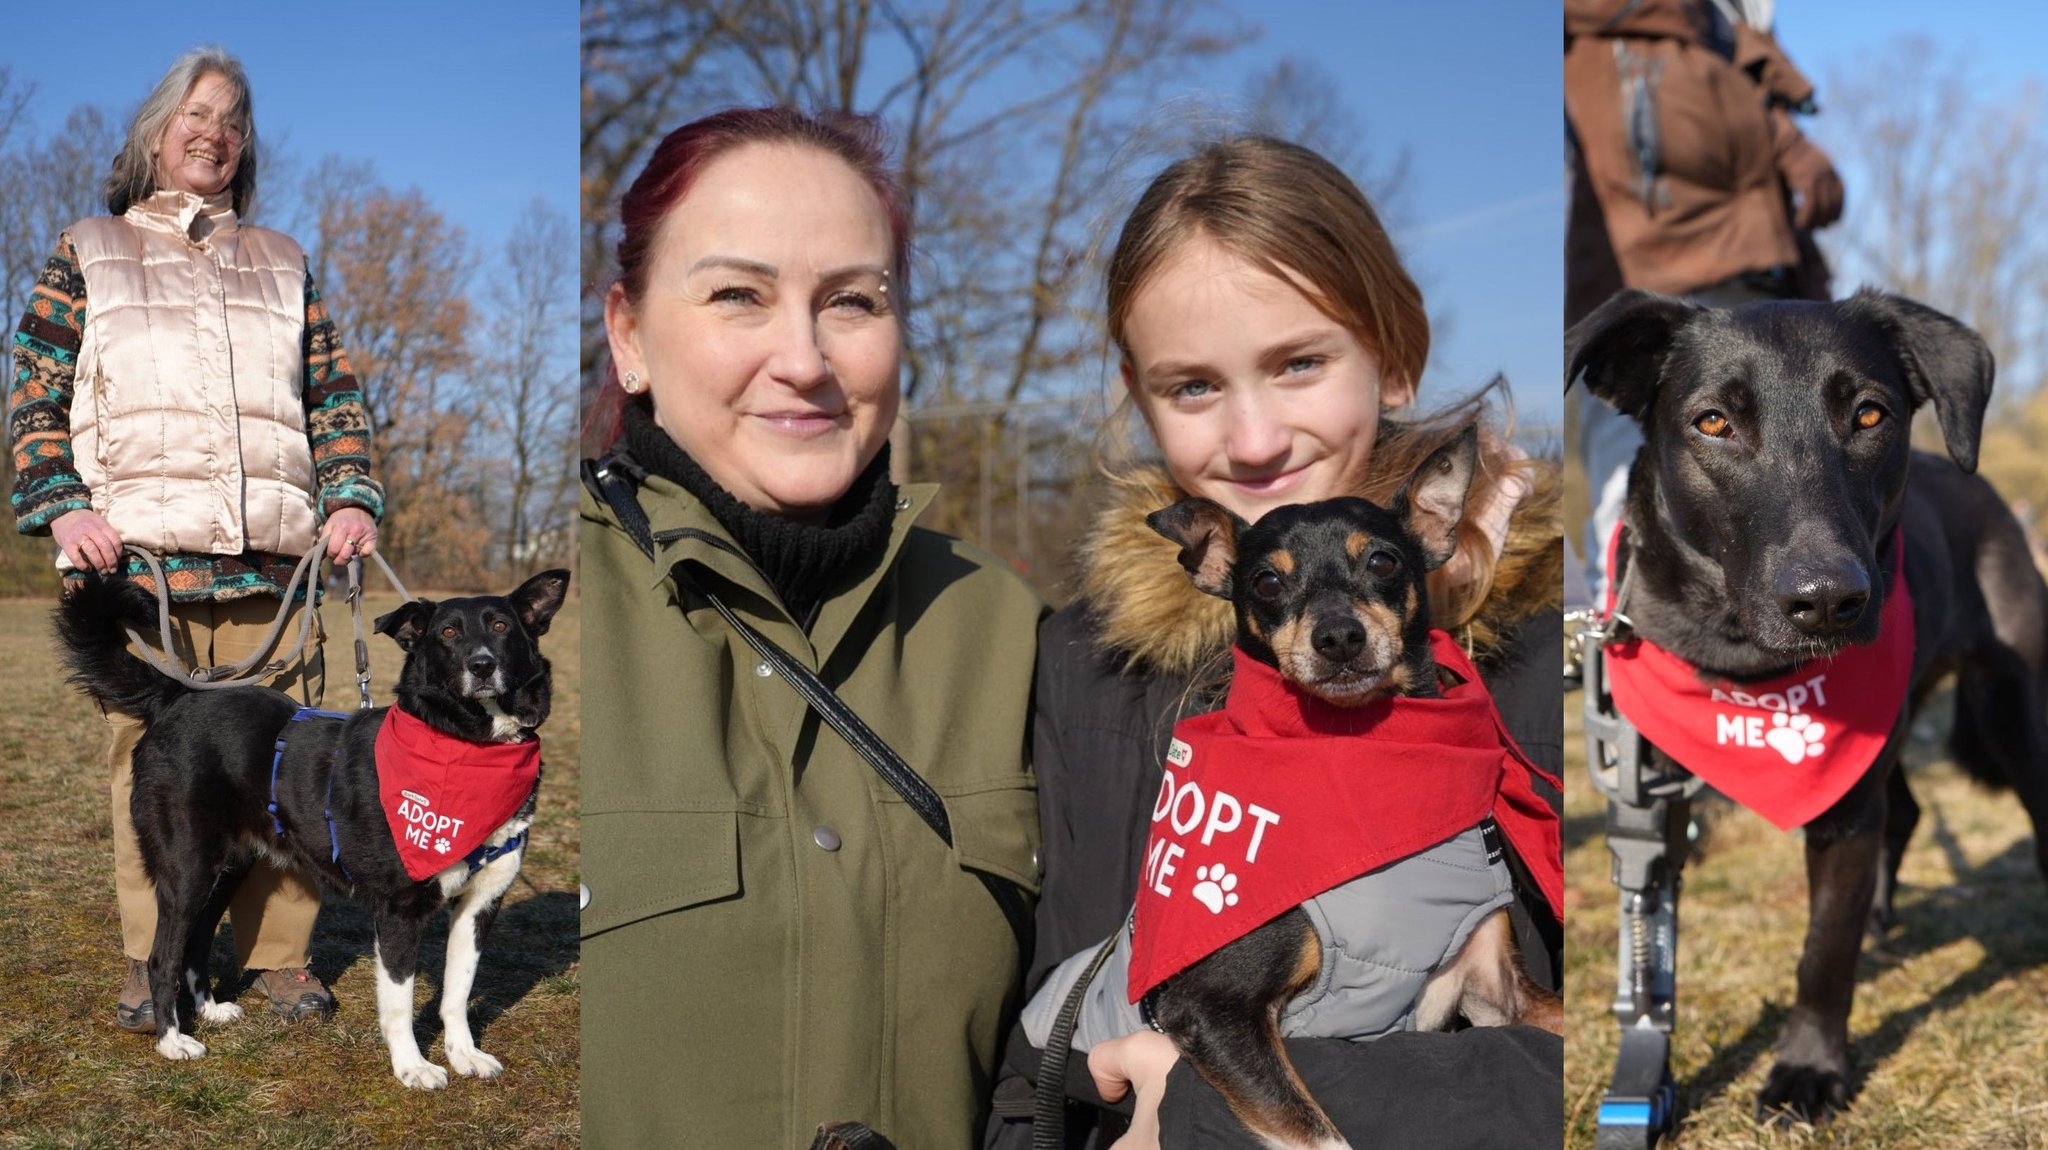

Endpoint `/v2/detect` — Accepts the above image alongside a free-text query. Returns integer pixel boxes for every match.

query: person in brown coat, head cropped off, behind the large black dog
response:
[1565,0,1843,600]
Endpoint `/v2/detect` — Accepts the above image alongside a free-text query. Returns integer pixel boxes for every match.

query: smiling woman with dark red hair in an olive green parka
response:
[582,108,1044,1146]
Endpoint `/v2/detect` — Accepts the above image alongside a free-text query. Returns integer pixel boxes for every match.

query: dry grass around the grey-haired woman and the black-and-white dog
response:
[0,593,580,1150]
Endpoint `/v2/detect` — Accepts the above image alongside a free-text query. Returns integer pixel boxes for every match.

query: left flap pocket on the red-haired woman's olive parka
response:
[582,810,739,939]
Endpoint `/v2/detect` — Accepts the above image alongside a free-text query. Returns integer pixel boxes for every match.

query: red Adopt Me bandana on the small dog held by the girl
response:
[1128,630,1565,1003]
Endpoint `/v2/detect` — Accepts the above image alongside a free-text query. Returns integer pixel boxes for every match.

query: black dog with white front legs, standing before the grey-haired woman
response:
[57,571,569,1089]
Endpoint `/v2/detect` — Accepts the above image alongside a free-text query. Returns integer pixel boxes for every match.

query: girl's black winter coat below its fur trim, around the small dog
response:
[985,600,1563,1150]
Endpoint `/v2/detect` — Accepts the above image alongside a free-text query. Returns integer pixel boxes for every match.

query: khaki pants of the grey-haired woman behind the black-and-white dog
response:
[106,598,326,970]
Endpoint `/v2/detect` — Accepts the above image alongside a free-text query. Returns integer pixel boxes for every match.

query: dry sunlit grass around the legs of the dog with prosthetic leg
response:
[1565,694,2048,1150]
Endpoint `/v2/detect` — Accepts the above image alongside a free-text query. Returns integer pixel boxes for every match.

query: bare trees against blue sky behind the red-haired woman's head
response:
[582,0,1241,403]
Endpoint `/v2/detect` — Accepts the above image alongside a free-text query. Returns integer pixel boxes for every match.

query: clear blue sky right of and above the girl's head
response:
[1155,0,1565,428]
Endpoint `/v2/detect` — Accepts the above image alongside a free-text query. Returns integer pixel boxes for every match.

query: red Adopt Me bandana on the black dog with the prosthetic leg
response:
[1608,528,1913,831]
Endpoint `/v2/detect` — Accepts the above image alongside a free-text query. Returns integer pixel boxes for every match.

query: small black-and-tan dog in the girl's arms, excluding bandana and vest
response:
[1147,430,1563,1148]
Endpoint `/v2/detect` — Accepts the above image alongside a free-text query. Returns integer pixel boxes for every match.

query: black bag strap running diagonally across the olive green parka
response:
[584,452,1032,964]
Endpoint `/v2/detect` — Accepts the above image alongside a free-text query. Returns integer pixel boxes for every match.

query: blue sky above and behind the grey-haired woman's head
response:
[0,0,580,284]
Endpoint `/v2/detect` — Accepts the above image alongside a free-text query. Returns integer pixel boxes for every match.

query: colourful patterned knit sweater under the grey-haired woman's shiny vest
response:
[8,233,383,602]
